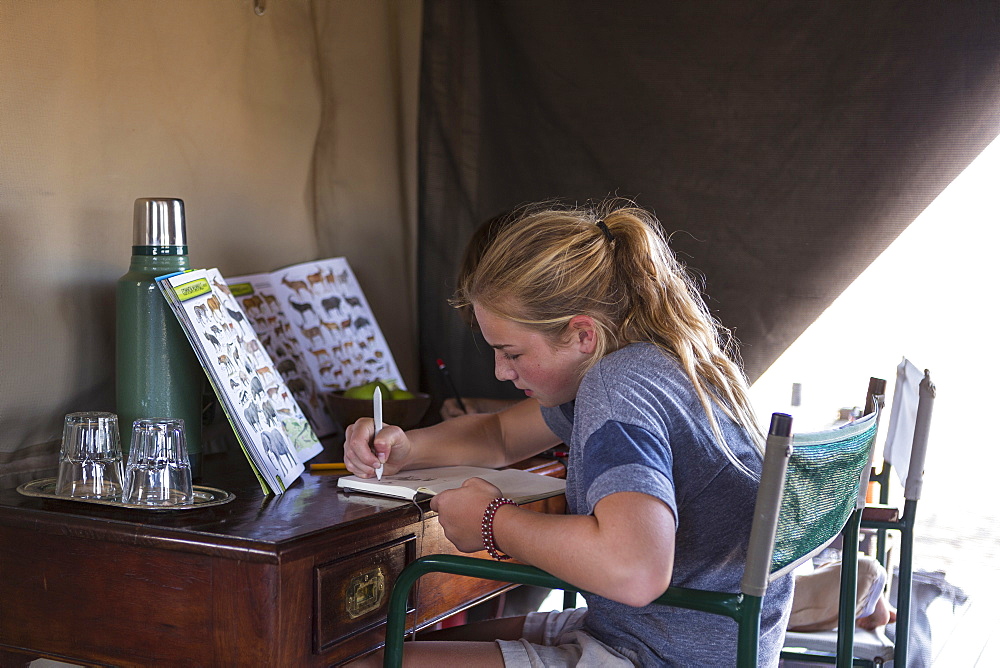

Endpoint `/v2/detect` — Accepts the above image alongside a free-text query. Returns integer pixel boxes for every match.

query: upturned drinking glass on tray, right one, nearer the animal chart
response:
[122,418,194,506]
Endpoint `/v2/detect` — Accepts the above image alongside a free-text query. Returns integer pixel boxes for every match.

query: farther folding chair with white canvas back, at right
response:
[782,358,936,668]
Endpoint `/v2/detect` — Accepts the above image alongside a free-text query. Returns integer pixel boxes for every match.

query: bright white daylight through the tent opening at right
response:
[751,130,1000,577]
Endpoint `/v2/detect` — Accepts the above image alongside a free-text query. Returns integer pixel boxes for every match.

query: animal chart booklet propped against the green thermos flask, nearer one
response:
[156,269,323,494]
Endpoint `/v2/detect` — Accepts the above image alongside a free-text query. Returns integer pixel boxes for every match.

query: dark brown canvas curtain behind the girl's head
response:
[419,0,1000,408]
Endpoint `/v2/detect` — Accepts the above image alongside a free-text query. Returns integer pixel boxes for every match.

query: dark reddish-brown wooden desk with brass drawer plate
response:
[0,455,565,668]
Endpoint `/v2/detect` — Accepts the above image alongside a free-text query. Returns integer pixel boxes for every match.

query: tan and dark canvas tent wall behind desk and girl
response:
[0,0,1000,484]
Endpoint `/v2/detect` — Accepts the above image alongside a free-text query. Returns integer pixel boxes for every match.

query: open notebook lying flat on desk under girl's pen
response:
[337,466,566,504]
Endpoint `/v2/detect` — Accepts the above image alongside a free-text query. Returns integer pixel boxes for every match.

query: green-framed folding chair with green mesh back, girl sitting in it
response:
[384,412,878,668]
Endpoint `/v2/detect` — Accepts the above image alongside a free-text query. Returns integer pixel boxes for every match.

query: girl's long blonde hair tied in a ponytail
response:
[451,200,762,446]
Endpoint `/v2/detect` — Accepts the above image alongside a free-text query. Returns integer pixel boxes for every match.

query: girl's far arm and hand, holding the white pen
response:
[344,399,559,478]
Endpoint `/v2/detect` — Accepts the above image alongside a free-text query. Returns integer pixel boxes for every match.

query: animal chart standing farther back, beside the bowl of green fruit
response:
[227,257,406,436]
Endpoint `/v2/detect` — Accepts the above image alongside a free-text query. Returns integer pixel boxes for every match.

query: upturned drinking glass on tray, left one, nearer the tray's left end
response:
[56,411,122,499]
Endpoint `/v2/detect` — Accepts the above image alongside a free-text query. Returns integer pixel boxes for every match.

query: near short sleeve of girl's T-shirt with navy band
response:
[582,420,678,521]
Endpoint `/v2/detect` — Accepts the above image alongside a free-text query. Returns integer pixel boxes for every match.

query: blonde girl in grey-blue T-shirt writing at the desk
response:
[344,204,791,666]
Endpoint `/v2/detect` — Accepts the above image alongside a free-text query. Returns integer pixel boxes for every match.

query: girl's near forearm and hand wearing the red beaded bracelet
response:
[431,480,676,606]
